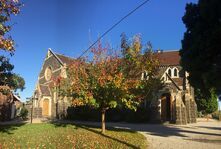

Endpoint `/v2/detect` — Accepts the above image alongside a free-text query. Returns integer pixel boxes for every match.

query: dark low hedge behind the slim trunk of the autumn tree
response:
[67,106,150,123]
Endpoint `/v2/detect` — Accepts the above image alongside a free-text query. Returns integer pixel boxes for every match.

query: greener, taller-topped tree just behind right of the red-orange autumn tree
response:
[121,33,164,105]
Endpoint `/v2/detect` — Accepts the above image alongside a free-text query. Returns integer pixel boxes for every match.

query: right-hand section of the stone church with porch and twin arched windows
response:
[152,50,197,124]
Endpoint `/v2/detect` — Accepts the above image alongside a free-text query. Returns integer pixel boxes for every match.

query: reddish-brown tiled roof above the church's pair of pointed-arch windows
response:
[156,51,180,66]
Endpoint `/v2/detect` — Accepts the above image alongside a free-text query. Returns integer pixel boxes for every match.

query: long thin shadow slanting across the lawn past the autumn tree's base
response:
[51,122,139,149]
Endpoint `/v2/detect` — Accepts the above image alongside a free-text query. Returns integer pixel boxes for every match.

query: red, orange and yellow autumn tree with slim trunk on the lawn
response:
[58,43,139,133]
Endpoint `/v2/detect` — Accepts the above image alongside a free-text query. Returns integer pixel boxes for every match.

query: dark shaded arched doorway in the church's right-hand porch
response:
[161,93,171,122]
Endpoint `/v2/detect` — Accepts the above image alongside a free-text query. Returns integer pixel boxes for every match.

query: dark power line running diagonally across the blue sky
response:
[78,0,150,59]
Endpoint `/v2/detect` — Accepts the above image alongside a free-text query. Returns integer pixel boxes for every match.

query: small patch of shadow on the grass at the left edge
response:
[0,122,26,134]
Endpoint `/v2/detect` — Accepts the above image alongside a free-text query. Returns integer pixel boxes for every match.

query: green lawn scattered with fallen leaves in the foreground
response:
[0,123,147,149]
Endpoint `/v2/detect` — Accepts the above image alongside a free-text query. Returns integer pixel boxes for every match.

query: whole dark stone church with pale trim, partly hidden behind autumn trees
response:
[33,49,197,124]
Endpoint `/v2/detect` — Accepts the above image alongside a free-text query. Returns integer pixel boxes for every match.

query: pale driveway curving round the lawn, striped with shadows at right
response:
[71,120,221,149]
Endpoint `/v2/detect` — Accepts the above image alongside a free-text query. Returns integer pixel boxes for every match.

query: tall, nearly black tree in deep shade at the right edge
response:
[180,0,221,96]
